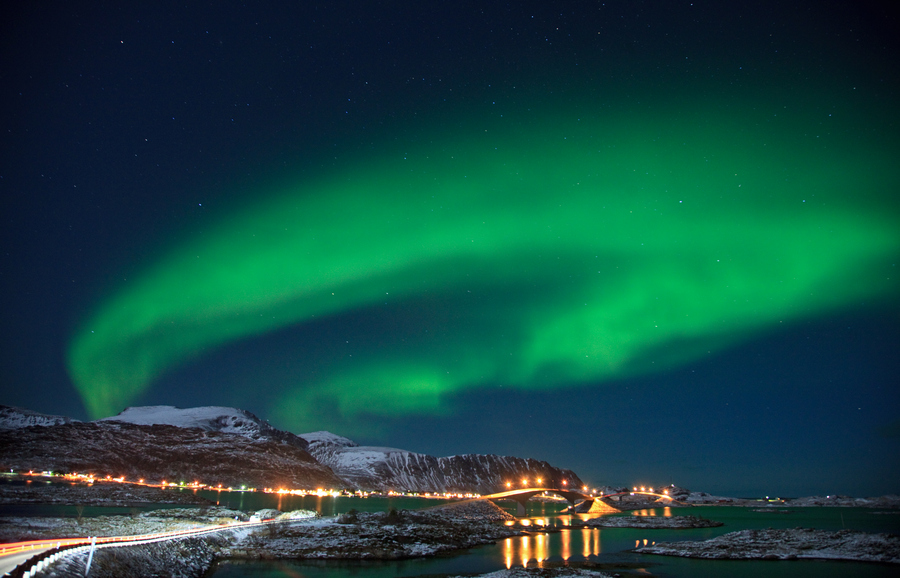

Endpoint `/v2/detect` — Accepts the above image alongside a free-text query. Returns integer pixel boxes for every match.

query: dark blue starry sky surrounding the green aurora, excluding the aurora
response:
[0,2,900,495]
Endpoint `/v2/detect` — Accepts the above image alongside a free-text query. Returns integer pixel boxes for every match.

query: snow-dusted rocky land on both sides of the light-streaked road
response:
[22,502,520,578]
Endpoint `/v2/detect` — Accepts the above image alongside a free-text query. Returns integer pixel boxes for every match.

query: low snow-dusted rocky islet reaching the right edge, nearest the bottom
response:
[637,528,900,564]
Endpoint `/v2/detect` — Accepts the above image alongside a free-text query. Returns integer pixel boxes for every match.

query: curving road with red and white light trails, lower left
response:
[0,520,272,576]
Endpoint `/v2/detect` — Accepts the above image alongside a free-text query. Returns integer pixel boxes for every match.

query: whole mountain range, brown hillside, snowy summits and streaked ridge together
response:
[0,406,581,494]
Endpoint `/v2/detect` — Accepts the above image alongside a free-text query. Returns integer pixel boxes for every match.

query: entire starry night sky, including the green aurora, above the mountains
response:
[0,1,900,496]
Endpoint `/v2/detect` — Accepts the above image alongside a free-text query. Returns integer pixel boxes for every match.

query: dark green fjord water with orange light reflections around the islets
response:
[212,498,900,578]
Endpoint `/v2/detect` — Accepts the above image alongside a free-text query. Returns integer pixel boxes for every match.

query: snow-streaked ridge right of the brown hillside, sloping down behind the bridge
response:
[300,431,582,494]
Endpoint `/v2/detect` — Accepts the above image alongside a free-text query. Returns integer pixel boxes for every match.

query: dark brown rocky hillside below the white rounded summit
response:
[0,421,343,489]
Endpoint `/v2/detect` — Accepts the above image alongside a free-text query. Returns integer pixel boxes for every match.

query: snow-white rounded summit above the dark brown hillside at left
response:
[97,405,307,449]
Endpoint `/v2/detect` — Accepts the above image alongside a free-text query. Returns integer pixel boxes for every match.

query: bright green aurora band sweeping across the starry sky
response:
[68,101,900,429]
